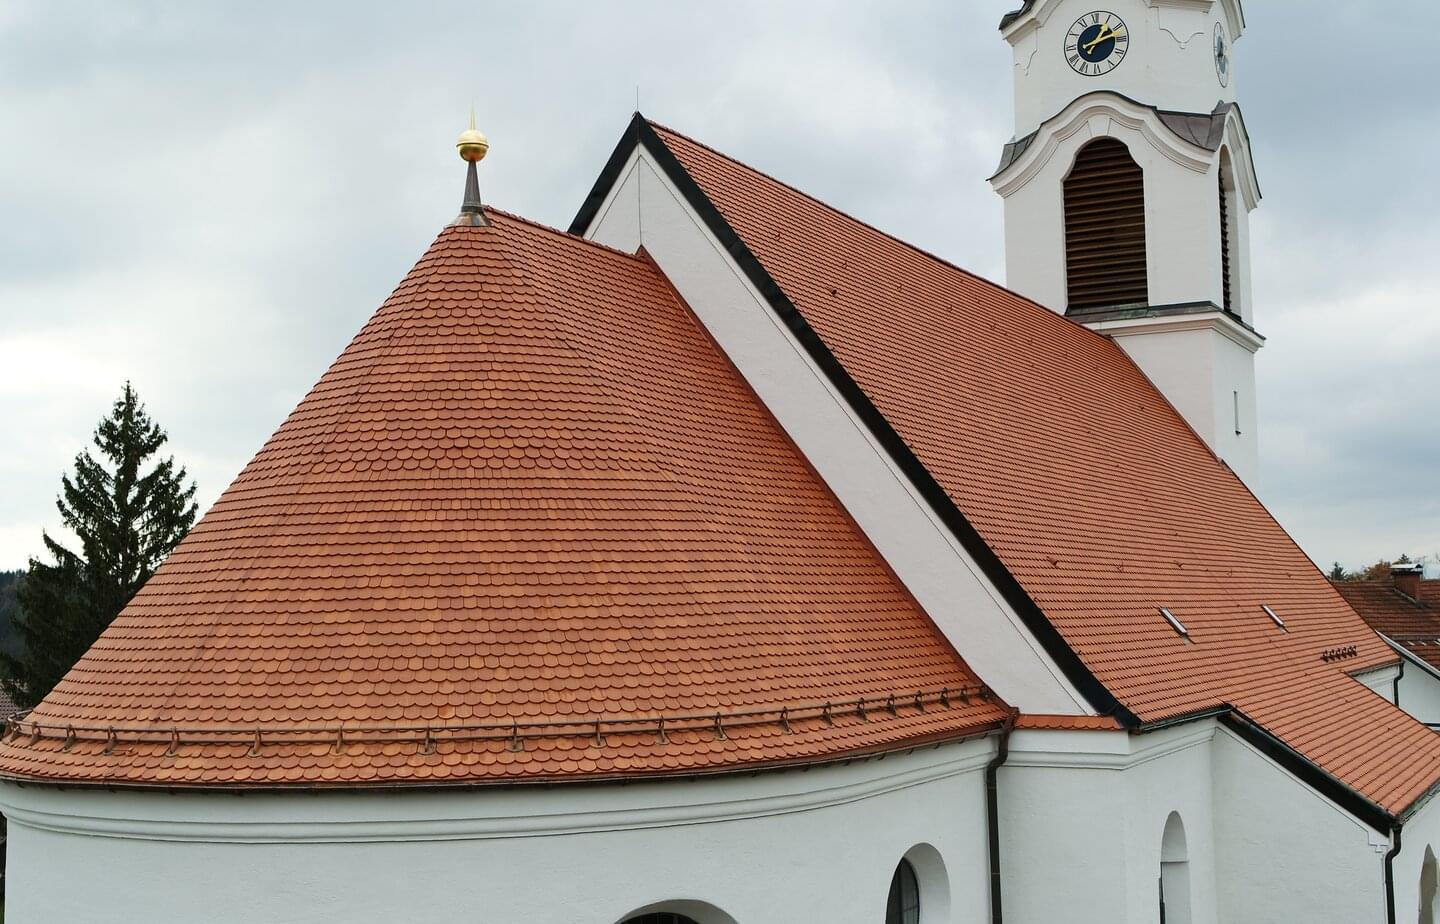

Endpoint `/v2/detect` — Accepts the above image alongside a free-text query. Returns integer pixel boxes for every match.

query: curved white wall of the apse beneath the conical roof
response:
[0,740,994,924]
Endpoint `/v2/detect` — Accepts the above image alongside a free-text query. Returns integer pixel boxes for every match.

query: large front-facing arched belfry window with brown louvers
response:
[1066,138,1149,311]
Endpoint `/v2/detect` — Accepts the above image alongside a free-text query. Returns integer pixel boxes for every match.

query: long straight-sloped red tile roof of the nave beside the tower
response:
[636,124,1440,812]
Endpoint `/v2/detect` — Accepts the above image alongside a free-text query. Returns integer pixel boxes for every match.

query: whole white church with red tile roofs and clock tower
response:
[0,0,1440,924]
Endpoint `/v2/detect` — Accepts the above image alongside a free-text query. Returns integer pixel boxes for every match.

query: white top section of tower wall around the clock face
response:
[1005,0,1240,135]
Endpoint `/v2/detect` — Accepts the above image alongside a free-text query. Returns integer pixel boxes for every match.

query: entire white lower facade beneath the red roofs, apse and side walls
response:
[0,720,1440,924]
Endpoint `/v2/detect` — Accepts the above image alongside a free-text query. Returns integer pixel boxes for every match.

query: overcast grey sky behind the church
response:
[0,0,1440,567]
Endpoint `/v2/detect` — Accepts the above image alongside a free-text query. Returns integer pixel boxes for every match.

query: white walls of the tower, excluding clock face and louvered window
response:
[991,0,1264,486]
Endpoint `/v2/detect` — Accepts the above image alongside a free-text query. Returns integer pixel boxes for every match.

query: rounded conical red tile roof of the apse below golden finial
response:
[0,213,1005,786]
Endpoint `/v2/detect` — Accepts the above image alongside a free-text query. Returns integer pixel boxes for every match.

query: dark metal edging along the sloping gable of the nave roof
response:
[570,112,1140,728]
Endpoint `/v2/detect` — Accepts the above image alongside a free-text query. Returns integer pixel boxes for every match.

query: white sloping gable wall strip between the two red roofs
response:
[586,150,1089,714]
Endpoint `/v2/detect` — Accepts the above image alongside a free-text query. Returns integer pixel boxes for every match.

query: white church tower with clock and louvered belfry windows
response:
[991,0,1264,485]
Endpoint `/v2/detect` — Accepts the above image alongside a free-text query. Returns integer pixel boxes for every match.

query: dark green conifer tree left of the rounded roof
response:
[0,381,196,708]
